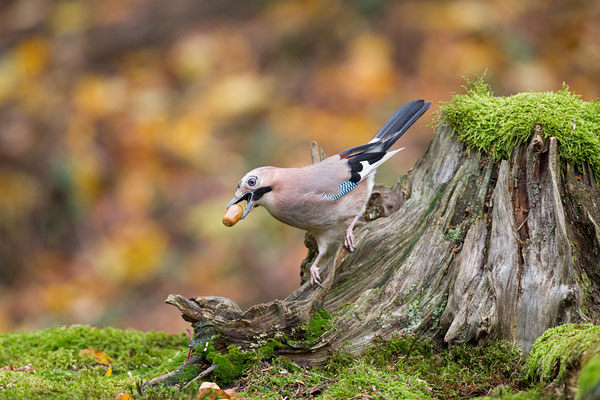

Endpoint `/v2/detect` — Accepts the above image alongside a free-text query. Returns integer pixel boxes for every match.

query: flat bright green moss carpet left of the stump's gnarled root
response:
[0,326,188,400]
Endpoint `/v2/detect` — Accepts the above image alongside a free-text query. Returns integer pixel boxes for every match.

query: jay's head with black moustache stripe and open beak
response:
[227,167,276,219]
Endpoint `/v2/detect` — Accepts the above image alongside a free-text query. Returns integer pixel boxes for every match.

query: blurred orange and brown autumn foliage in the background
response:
[0,0,600,332]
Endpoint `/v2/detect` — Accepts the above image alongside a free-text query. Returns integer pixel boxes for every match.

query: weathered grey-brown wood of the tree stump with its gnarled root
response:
[156,124,600,384]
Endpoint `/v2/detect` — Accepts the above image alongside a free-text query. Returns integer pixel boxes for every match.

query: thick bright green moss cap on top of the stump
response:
[438,77,600,179]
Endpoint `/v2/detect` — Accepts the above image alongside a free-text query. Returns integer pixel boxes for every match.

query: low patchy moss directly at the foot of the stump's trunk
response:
[240,336,528,399]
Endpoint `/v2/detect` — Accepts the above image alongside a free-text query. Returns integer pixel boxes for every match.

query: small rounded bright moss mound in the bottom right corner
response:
[527,324,600,382]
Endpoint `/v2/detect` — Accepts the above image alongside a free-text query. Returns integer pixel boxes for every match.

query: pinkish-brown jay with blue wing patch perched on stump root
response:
[227,100,431,286]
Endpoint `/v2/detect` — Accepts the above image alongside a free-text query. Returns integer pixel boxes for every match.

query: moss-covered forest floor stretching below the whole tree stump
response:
[0,324,600,399]
